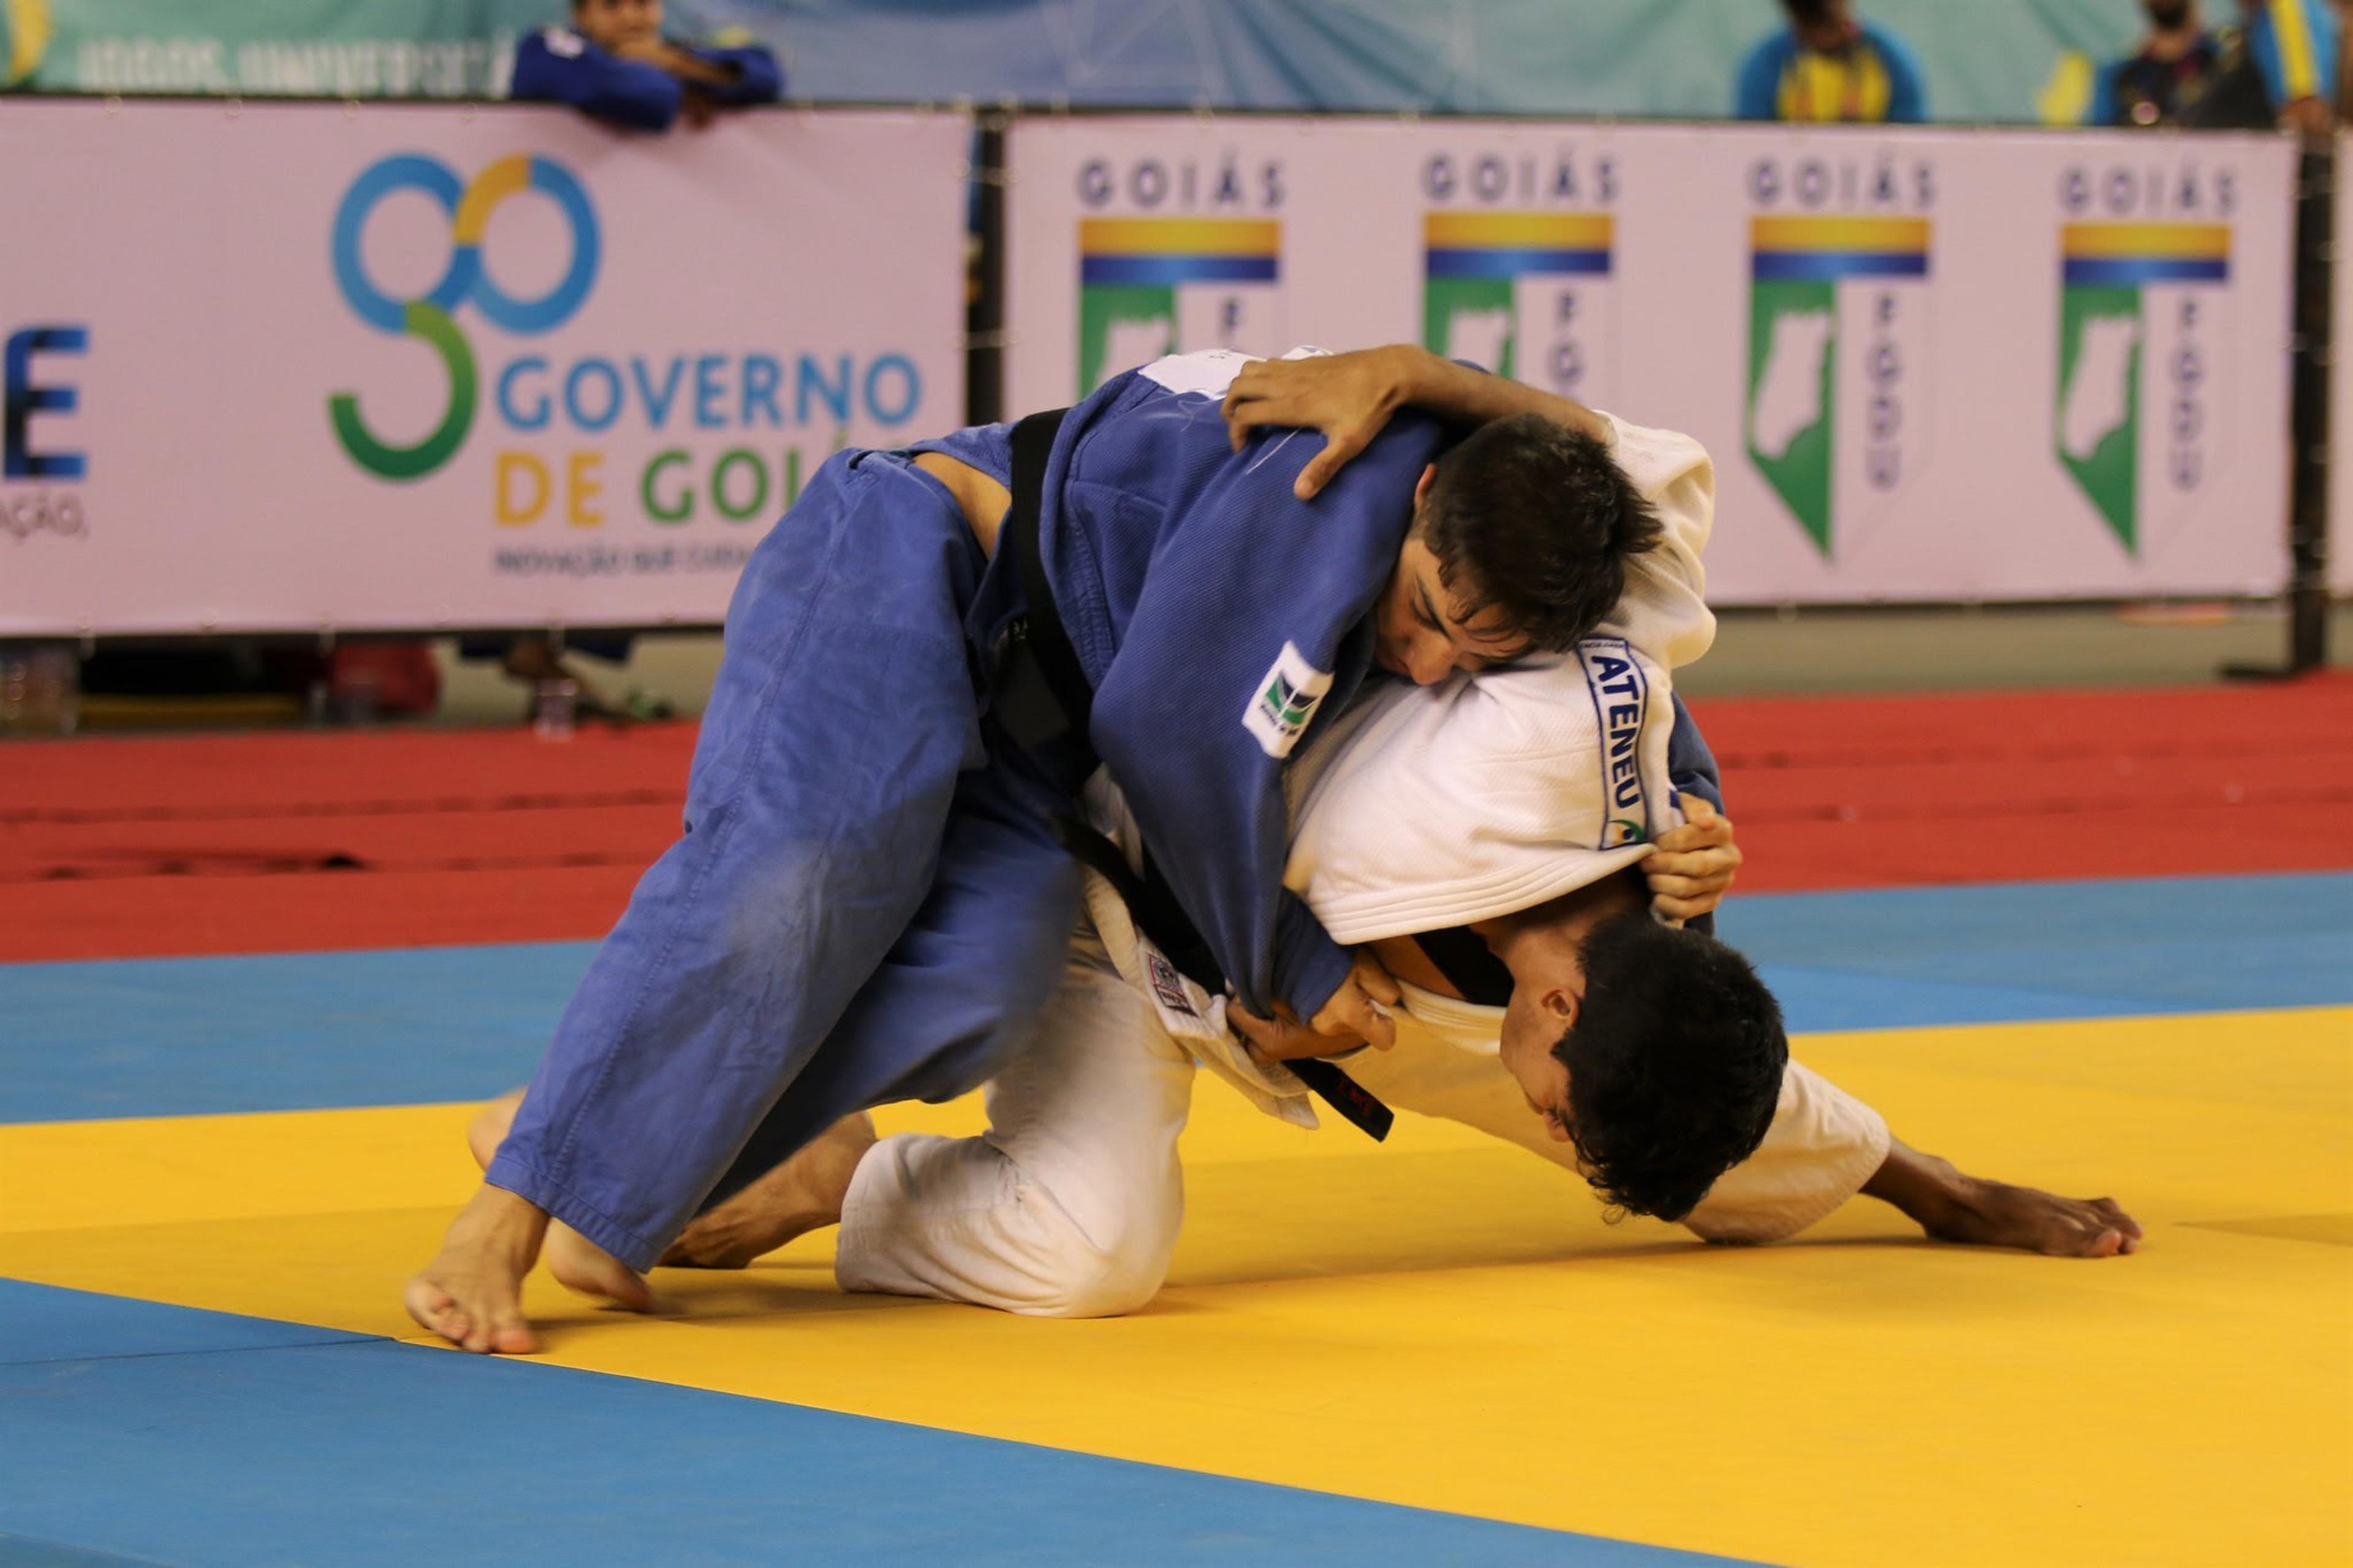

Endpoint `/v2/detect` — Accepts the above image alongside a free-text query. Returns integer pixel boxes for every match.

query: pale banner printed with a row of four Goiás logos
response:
[1007,118,2292,603]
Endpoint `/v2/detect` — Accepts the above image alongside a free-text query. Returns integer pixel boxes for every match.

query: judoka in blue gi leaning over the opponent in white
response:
[407,353,1656,1352]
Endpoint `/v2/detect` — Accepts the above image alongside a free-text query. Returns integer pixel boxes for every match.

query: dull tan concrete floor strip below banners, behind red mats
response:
[438,603,2353,725]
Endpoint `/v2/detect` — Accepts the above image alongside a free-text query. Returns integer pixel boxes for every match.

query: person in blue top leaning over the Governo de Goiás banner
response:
[508,0,784,132]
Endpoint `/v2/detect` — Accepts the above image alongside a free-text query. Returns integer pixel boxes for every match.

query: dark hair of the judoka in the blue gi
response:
[1414,414,1659,652]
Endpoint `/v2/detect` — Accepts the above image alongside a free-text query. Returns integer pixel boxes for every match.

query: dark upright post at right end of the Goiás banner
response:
[2221,137,2336,680]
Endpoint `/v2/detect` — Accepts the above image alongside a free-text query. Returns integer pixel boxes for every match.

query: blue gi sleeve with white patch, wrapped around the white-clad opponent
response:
[1089,419,1438,1020]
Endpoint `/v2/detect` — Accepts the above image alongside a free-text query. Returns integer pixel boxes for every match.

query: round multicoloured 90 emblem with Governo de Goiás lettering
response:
[327,153,925,537]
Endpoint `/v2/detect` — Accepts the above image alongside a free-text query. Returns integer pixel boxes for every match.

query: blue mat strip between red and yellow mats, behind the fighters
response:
[0,874,2353,1121]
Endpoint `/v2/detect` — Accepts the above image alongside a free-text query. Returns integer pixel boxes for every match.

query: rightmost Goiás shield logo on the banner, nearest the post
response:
[2052,160,2238,556]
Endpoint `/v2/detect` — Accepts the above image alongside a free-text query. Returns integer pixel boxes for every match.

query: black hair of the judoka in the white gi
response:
[1553,909,1788,1219]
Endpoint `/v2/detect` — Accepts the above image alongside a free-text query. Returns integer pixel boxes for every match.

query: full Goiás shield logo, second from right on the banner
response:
[1743,156,1936,558]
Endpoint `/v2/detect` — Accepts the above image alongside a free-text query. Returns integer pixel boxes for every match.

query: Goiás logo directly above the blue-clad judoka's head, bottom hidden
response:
[1421,146,1619,403]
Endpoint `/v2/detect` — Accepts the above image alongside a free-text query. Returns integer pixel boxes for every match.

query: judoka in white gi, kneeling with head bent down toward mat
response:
[482,351,2139,1316]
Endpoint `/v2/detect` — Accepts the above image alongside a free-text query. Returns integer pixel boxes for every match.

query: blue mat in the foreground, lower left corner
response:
[0,1283,1727,1568]
